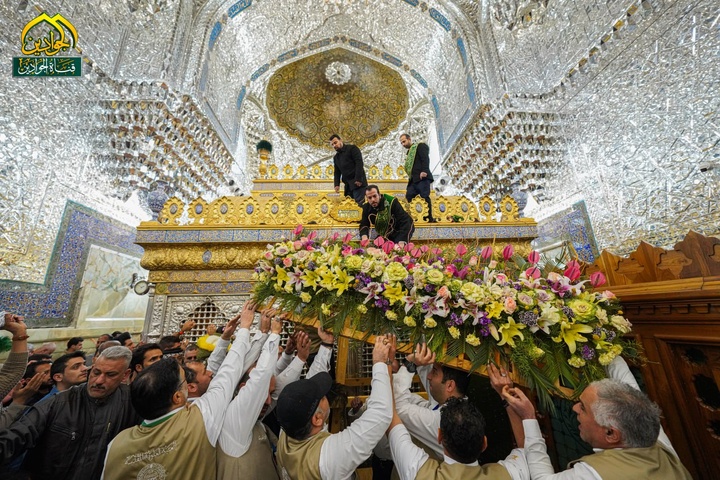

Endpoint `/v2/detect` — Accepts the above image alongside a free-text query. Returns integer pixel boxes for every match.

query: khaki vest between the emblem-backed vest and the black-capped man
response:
[217,422,280,480]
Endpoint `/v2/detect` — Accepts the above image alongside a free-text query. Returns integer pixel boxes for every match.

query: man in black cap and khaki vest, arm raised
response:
[276,336,395,480]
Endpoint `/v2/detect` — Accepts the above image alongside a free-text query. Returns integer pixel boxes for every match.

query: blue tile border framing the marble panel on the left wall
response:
[0,201,143,327]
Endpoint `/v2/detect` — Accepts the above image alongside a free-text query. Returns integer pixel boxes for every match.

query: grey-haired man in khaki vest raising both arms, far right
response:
[502,357,692,480]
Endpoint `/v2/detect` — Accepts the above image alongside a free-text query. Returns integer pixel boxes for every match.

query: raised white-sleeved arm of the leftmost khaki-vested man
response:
[194,301,255,446]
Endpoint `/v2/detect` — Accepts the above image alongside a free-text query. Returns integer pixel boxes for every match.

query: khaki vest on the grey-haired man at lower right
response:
[571,443,692,480]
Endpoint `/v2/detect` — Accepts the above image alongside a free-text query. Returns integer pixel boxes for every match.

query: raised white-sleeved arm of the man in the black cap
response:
[320,335,392,480]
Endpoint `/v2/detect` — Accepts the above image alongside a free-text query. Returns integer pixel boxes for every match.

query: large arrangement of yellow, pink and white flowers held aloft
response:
[254,227,638,408]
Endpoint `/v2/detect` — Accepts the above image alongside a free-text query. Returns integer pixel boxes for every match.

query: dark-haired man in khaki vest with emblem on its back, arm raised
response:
[103,302,255,480]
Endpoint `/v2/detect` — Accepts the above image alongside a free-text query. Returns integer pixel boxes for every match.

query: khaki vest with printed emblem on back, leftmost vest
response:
[104,406,216,480]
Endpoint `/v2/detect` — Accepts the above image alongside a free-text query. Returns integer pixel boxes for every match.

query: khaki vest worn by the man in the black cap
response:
[277,431,330,480]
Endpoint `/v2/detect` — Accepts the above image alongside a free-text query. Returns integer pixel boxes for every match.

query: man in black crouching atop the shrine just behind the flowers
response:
[360,185,415,244]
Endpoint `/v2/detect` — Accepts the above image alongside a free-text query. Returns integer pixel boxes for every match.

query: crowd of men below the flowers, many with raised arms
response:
[0,302,691,480]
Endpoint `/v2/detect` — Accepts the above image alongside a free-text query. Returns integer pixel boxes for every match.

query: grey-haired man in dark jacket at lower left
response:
[0,346,141,480]
